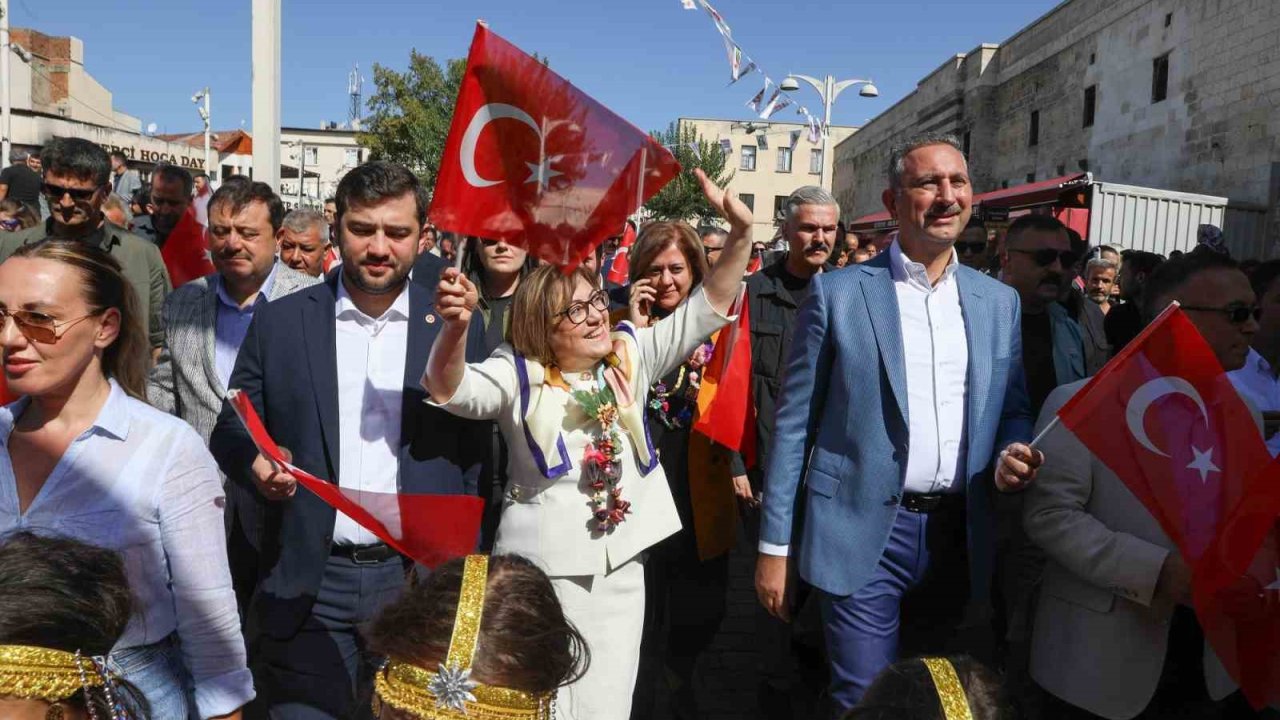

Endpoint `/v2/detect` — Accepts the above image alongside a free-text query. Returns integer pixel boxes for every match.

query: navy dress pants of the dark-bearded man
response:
[246,556,404,720]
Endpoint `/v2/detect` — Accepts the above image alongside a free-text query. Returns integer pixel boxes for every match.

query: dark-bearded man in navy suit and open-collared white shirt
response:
[210,163,484,720]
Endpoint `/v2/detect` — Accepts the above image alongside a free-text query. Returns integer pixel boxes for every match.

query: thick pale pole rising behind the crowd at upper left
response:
[252,0,280,191]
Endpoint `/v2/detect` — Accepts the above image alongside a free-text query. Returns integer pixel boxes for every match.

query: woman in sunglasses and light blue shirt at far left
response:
[0,240,253,719]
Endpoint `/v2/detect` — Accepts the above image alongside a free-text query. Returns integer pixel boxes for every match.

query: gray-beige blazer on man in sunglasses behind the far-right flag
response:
[1023,380,1236,720]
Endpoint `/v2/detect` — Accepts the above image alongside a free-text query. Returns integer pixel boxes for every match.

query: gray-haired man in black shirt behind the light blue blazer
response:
[732,186,840,719]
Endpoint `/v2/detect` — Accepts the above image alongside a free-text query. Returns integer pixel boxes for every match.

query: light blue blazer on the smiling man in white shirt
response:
[760,252,1033,601]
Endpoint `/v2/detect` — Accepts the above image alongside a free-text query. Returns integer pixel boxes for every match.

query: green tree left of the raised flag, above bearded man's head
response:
[356,50,466,187]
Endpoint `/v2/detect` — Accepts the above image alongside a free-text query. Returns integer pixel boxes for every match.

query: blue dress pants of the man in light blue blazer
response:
[820,495,972,717]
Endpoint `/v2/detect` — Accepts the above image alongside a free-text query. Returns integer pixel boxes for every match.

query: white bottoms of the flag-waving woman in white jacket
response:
[552,559,644,720]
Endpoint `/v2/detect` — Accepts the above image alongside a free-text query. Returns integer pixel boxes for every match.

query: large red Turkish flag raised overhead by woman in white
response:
[430,23,680,270]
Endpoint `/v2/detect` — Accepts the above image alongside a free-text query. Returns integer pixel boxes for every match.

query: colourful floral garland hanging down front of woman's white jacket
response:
[572,366,631,533]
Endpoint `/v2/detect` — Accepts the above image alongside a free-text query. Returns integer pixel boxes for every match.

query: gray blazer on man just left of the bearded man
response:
[147,261,320,443]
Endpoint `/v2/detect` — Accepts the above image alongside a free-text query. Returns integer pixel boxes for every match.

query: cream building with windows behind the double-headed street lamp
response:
[678,118,858,242]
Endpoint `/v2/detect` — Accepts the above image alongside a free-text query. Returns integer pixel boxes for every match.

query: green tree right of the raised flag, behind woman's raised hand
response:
[644,123,733,224]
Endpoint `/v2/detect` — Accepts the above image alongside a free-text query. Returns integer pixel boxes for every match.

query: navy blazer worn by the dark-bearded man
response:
[210,270,488,637]
